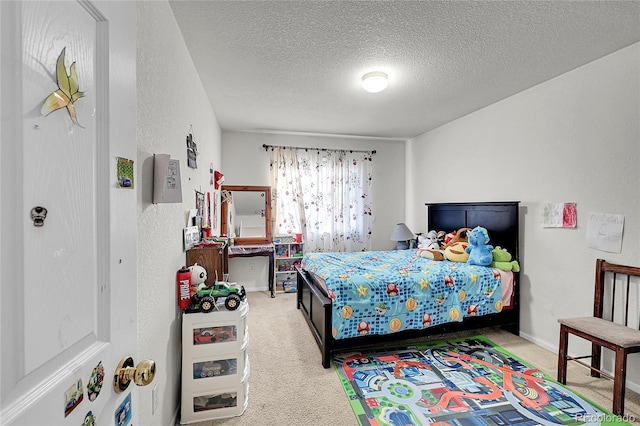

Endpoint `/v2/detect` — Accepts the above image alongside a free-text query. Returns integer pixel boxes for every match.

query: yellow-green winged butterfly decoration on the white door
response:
[40,47,84,127]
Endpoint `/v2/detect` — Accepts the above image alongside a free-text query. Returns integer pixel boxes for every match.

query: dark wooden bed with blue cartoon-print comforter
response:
[297,201,520,368]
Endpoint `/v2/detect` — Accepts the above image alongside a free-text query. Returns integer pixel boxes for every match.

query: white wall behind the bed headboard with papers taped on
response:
[407,44,640,383]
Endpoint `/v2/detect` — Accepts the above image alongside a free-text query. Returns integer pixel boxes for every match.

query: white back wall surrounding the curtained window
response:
[222,131,404,290]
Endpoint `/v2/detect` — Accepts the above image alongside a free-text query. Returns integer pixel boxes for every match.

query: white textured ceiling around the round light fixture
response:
[170,0,640,139]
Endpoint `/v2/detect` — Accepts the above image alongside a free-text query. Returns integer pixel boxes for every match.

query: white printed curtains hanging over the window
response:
[271,147,373,252]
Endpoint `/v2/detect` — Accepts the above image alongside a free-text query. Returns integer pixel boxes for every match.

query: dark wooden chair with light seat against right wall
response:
[558,259,640,416]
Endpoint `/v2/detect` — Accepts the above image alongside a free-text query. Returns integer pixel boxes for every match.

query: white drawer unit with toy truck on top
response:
[180,299,249,424]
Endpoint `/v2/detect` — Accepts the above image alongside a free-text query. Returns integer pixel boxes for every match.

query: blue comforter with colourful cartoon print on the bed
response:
[302,250,502,339]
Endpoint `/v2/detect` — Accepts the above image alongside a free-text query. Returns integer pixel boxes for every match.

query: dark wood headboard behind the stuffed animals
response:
[425,201,520,260]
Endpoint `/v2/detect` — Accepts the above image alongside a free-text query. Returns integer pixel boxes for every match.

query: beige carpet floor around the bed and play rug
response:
[182,292,640,426]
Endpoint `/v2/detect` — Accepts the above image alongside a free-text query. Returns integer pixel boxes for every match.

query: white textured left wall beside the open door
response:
[138,1,221,425]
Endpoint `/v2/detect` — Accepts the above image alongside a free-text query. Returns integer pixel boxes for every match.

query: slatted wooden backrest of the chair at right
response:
[593,259,640,329]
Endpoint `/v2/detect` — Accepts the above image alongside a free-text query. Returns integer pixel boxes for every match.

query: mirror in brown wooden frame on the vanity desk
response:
[220,185,271,244]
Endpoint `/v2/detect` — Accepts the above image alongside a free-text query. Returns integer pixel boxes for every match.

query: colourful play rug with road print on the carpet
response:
[333,337,629,426]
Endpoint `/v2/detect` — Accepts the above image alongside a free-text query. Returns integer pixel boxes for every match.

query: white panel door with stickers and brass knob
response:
[0,0,140,426]
